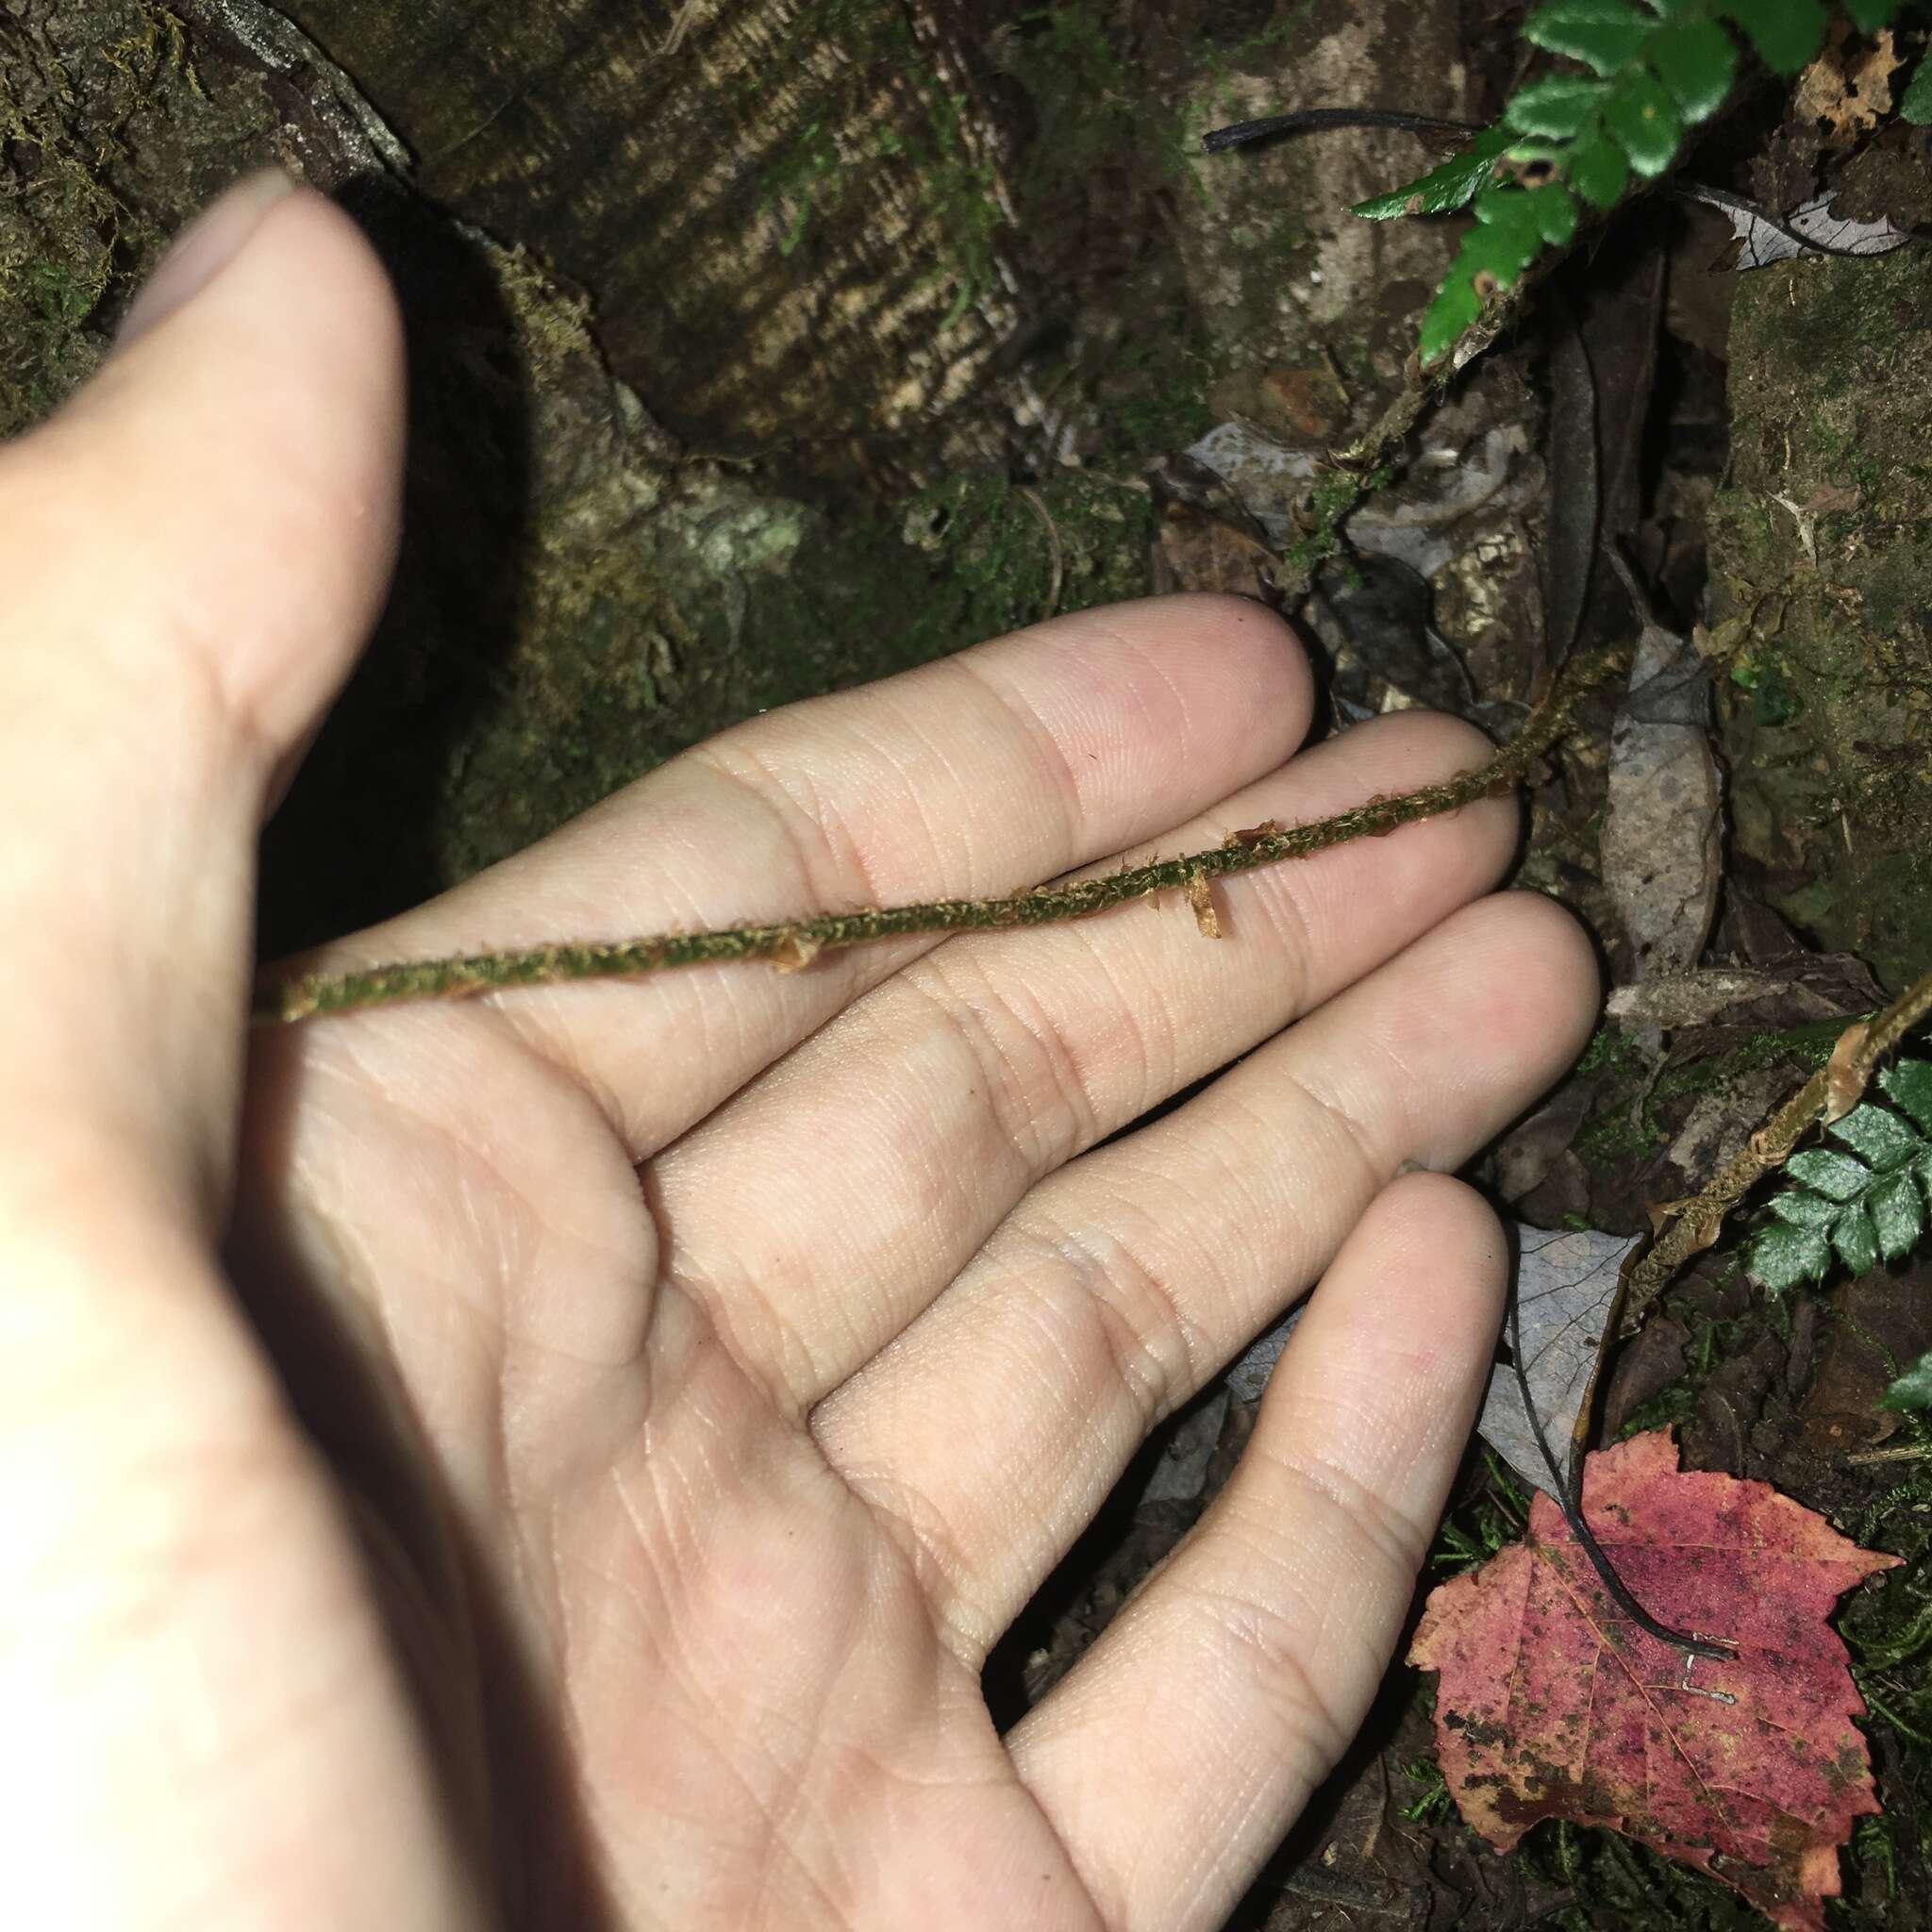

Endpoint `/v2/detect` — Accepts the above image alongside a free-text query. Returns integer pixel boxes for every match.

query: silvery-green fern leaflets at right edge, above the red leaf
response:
[1746,1060,1932,1294]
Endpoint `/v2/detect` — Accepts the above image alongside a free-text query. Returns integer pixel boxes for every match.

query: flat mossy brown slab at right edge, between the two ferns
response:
[1709,247,1932,990]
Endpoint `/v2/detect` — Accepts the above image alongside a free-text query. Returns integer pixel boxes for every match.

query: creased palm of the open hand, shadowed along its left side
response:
[242,1016,1093,1926]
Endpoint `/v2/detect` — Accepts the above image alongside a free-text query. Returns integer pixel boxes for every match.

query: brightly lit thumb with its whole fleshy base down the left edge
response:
[0,179,485,1928]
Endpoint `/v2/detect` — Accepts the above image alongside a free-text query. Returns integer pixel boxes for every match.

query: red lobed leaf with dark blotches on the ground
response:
[1408,1430,1899,1932]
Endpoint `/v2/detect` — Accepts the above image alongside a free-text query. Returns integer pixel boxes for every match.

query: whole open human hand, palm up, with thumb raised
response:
[0,184,1594,1932]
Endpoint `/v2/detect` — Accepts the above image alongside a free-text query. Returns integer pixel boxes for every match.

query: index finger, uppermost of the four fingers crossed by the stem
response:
[290,595,1310,1159]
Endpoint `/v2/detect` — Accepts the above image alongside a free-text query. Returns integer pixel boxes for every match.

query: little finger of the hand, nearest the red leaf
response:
[1008,1174,1503,1932]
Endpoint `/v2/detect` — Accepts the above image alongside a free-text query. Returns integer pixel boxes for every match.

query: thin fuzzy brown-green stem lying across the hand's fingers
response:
[253,643,1628,1024]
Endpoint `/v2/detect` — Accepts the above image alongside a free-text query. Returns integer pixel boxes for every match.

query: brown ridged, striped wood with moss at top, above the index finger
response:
[286,0,1020,466]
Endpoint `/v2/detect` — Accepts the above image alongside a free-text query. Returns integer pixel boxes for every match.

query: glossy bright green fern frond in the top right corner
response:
[1353,0,1932,363]
